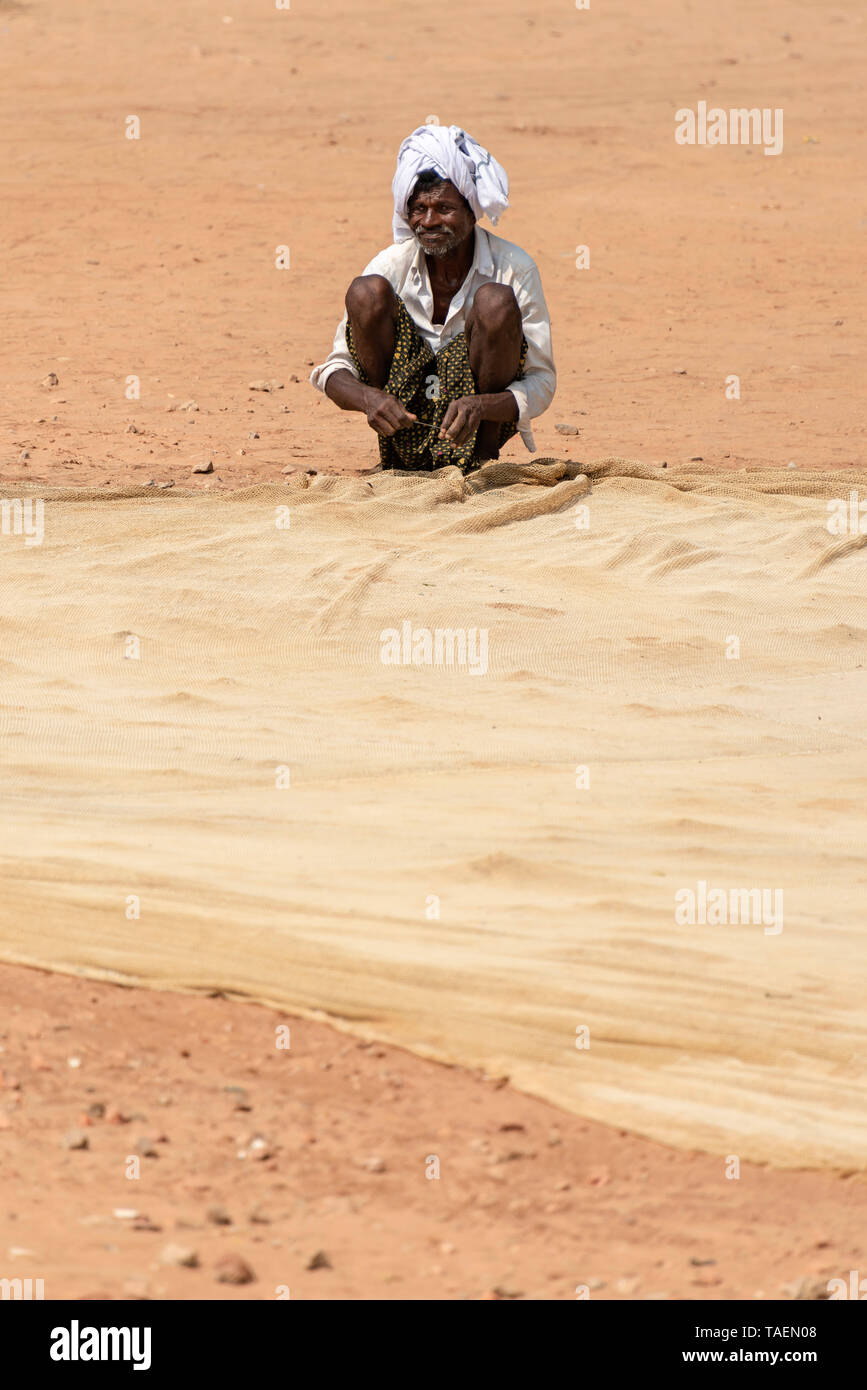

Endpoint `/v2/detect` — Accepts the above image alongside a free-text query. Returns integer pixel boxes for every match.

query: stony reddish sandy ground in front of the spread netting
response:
[0,966,867,1300]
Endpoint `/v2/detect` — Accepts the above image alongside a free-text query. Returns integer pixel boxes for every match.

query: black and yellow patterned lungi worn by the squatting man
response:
[346,295,527,473]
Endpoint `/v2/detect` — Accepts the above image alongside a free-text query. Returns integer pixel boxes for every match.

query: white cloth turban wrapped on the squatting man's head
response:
[392,125,509,242]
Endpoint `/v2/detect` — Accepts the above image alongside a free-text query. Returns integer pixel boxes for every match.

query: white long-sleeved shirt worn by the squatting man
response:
[310,225,557,453]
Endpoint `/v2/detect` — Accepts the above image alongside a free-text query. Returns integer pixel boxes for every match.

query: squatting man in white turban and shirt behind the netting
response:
[310,125,557,473]
